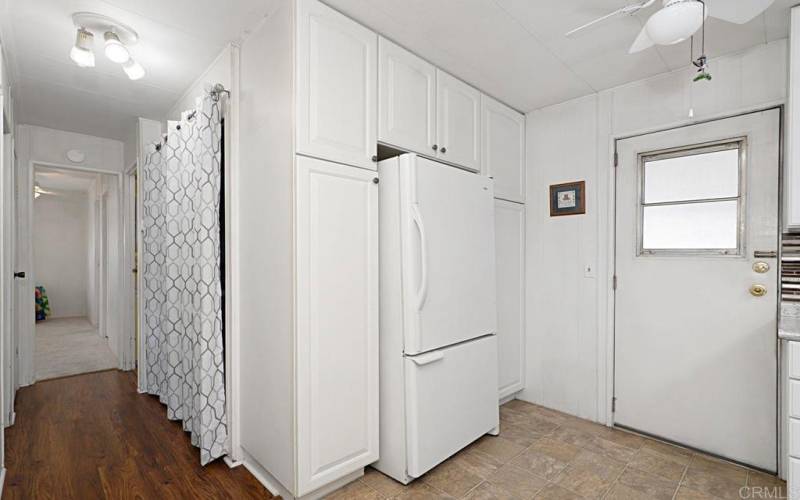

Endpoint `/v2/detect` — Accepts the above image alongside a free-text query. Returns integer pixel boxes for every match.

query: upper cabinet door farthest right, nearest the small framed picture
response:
[481,95,525,203]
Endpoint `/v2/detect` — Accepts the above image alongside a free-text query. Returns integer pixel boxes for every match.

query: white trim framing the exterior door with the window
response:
[598,102,786,468]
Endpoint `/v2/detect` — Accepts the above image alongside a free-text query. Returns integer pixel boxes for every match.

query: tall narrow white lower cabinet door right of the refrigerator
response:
[494,200,525,399]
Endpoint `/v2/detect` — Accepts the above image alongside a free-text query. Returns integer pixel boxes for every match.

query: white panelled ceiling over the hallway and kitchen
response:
[0,0,797,140]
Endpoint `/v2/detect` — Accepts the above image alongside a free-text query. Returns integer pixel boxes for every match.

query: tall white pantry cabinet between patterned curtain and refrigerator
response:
[236,0,379,498]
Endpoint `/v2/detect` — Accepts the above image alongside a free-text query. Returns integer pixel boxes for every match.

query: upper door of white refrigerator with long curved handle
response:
[400,155,497,355]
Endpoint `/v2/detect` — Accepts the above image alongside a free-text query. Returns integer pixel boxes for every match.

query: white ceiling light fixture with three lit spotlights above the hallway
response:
[70,12,145,80]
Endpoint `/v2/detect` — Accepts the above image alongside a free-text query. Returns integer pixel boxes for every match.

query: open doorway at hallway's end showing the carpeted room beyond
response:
[31,164,124,381]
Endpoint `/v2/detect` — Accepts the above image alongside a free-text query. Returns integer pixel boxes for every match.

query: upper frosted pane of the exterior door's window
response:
[644,148,739,203]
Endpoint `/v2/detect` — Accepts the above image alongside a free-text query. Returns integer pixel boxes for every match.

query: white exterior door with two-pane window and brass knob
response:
[614,110,780,471]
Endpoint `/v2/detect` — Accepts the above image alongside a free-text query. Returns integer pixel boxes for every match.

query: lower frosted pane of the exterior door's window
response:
[642,201,739,250]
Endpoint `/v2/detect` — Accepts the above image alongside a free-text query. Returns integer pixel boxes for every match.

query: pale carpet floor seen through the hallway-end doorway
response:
[34,318,118,380]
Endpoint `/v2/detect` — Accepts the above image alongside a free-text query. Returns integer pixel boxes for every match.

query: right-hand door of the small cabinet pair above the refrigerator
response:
[436,70,481,172]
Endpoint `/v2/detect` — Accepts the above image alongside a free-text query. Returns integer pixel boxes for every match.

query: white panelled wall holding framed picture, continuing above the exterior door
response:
[520,40,787,422]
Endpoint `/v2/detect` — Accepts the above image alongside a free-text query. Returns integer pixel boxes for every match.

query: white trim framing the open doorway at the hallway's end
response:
[18,158,133,385]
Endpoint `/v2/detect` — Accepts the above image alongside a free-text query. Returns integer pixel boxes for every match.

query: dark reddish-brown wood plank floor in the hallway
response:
[3,370,272,500]
